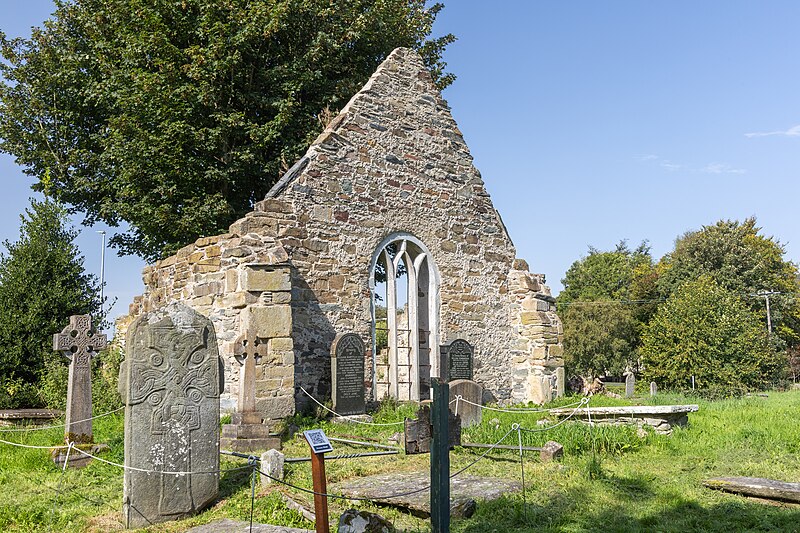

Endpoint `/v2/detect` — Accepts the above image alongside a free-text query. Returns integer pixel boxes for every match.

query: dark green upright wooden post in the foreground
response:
[431,378,450,533]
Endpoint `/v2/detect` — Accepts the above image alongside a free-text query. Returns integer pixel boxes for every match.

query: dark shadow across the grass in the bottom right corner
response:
[453,478,800,533]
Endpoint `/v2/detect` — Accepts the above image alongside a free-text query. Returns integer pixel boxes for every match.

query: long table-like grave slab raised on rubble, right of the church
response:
[549,405,700,435]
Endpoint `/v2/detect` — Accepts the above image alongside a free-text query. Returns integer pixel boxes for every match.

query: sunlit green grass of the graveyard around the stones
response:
[0,391,800,533]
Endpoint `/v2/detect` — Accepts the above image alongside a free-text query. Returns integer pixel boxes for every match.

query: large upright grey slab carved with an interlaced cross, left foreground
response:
[119,303,223,528]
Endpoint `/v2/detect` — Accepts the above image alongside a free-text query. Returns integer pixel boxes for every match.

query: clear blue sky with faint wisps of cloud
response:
[0,0,800,322]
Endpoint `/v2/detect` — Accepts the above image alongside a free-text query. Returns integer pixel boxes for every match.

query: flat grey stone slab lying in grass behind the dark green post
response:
[328,472,522,518]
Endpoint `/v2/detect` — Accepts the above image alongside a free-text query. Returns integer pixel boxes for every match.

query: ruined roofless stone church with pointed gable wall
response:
[118,48,563,419]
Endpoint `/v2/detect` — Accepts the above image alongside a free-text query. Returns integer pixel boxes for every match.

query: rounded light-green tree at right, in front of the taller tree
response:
[641,274,786,390]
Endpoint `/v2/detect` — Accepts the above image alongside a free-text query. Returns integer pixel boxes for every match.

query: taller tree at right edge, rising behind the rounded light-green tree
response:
[657,218,800,346]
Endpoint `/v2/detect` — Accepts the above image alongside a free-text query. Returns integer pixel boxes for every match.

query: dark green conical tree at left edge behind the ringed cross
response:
[0,199,100,406]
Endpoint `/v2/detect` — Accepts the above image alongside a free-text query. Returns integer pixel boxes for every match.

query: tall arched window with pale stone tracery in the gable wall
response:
[369,233,440,401]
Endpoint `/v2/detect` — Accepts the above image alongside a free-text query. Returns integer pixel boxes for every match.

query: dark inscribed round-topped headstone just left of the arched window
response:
[331,333,366,415]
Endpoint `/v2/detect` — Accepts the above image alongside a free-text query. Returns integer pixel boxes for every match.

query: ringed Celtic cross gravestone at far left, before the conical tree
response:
[53,315,108,443]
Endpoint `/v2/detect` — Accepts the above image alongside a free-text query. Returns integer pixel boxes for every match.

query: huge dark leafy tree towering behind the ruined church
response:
[0,0,455,259]
